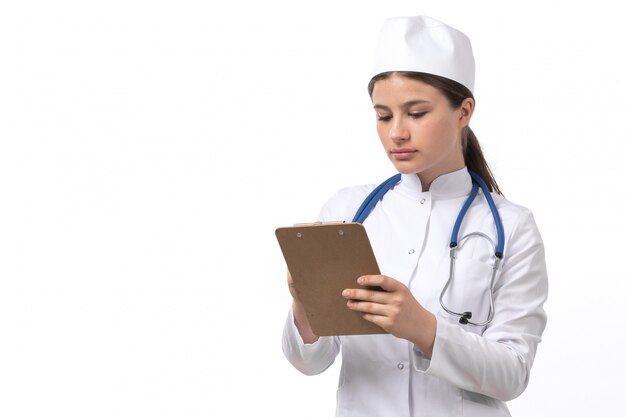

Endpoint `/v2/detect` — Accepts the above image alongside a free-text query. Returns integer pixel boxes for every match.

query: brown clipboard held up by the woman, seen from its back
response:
[276,222,387,336]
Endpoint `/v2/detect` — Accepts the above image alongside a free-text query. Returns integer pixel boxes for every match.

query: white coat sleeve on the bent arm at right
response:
[413,213,548,401]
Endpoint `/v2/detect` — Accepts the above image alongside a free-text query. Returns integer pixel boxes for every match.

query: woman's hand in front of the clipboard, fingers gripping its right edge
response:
[342,275,437,357]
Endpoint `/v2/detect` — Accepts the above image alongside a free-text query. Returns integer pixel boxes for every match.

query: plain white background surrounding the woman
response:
[0,0,626,417]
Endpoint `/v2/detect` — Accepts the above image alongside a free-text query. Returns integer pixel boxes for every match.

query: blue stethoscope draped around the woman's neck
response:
[352,169,504,326]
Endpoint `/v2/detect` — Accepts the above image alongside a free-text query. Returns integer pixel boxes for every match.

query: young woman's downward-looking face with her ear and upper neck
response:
[372,74,474,190]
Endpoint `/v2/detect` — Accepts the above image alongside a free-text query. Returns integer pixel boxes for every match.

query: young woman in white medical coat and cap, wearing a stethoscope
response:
[283,16,547,417]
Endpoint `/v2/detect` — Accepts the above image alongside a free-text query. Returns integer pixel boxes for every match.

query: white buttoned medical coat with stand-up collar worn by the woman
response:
[283,168,548,417]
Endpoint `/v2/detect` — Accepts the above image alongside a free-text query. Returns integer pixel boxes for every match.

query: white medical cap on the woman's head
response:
[372,16,475,92]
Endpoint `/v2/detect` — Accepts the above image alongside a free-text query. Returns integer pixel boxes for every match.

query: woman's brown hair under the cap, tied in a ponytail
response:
[367,71,502,194]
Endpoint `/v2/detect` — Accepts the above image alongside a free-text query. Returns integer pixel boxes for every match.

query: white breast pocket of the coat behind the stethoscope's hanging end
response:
[439,259,493,334]
